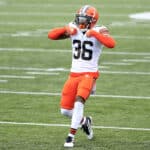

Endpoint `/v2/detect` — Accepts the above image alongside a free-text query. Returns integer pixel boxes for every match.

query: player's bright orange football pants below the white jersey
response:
[60,72,99,110]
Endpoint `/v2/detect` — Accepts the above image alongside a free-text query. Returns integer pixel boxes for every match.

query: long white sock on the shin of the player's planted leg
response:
[71,101,84,129]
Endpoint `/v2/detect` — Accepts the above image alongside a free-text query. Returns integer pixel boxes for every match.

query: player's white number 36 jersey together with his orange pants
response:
[61,23,104,109]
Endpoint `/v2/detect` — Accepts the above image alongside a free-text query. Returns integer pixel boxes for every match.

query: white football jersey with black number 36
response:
[69,23,104,73]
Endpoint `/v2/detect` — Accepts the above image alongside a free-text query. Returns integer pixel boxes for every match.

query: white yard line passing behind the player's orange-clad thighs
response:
[0,90,150,100]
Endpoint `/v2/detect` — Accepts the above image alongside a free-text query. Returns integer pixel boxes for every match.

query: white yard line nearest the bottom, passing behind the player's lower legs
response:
[0,121,150,131]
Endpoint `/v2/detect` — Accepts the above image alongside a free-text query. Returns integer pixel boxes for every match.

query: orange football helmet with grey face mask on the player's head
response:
[75,5,99,32]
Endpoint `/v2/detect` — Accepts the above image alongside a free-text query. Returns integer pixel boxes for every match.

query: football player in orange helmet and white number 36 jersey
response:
[48,5,116,147]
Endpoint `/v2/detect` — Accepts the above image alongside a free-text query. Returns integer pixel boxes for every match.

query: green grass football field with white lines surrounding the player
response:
[0,0,150,150]
